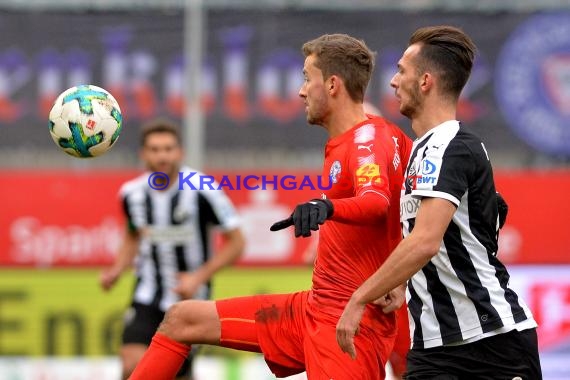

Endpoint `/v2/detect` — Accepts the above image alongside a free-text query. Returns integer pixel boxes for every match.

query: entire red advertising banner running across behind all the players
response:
[0,170,570,267]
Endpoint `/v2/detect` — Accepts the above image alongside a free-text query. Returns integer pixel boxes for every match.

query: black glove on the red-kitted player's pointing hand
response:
[270,199,333,237]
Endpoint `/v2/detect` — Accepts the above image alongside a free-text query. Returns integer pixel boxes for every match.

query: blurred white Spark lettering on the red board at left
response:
[10,216,123,265]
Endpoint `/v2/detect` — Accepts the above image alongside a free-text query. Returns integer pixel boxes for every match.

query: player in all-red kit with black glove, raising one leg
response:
[127,34,412,380]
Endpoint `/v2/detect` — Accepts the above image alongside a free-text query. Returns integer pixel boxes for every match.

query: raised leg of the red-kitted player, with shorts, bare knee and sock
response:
[130,292,306,380]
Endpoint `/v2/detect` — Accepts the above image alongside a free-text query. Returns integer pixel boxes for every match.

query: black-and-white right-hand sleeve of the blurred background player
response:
[199,184,240,231]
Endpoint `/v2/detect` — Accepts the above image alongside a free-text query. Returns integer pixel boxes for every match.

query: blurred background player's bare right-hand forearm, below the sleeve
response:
[174,228,245,299]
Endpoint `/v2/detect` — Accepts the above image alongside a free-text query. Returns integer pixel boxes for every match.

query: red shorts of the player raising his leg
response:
[216,291,395,380]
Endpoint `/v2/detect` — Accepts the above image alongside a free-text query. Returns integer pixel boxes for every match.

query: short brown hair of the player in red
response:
[303,34,375,102]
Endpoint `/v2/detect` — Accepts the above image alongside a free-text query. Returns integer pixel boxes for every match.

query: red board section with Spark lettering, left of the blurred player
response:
[0,171,132,266]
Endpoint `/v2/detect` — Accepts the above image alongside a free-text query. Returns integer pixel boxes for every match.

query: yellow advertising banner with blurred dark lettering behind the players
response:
[0,266,311,356]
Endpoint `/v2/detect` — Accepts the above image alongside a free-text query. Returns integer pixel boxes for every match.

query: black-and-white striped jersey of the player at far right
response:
[401,121,536,348]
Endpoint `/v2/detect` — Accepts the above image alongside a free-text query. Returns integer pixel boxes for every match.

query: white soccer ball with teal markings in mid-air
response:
[49,84,123,157]
